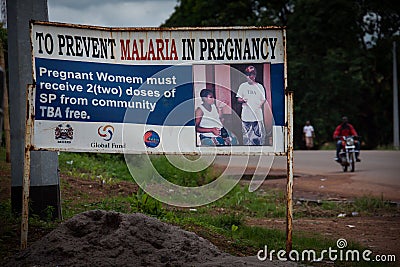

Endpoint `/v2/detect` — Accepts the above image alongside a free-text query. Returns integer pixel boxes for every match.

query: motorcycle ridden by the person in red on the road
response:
[339,136,359,172]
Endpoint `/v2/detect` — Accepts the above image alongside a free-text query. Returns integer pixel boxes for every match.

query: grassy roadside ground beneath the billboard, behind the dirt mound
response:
[0,149,397,266]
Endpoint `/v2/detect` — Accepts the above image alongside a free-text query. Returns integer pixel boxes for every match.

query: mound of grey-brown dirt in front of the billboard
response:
[6,210,294,266]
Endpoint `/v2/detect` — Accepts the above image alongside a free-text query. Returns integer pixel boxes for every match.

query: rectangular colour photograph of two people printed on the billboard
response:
[193,63,273,149]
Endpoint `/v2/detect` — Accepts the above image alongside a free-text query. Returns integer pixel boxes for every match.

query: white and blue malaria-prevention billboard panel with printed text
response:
[31,22,286,154]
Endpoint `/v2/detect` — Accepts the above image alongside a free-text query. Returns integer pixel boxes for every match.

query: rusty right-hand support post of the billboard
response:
[286,91,293,253]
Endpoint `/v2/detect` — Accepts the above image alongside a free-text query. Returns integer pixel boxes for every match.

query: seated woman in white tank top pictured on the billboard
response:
[195,89,237,146]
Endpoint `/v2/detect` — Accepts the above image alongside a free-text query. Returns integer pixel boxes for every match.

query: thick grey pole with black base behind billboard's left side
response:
[7,0,61,223]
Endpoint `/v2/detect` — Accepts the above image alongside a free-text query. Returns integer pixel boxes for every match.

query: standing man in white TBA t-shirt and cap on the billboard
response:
[237,66,266,146]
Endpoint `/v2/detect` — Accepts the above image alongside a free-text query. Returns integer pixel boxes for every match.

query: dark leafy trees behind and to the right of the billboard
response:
[162,0,400,148]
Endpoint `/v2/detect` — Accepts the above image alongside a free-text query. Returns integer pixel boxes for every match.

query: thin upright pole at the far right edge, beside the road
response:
[393,41,399,149]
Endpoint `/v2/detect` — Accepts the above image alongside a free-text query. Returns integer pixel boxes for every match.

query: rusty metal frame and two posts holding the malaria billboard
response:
[21,21,293,252]
